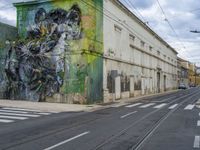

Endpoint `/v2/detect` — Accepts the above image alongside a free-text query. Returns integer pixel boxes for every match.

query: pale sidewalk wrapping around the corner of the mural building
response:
[0,90,178,112]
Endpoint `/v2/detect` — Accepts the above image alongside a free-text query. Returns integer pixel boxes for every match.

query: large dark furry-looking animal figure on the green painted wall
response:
[5,4,82,101]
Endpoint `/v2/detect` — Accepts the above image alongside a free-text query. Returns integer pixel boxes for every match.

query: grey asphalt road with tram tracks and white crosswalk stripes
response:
[0,88,200,150]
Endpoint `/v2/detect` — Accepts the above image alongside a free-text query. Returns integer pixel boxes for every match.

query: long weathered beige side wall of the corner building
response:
[103,0,177,102]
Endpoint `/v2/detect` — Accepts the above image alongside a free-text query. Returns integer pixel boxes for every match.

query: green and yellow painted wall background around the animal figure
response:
[16,0,103,103]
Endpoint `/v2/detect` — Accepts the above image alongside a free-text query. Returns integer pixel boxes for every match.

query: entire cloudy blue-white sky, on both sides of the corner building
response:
[0,0,200,66]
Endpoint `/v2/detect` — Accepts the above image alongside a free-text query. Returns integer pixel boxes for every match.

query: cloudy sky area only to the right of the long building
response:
[122,0,200,65]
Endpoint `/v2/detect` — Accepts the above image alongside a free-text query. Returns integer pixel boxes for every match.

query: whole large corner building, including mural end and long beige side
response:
[0,0,177,103]
